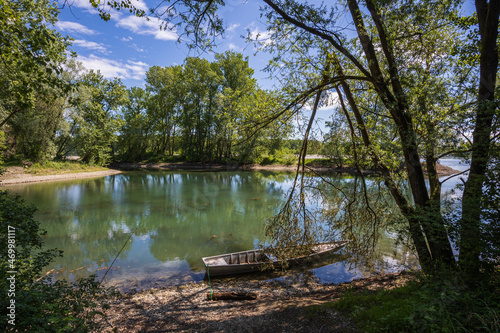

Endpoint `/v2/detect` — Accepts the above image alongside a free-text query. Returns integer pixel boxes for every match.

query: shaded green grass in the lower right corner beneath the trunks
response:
[320,274,500,332]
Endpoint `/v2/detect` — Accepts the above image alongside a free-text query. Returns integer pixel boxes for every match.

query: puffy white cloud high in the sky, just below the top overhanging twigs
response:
[115,15,179,41]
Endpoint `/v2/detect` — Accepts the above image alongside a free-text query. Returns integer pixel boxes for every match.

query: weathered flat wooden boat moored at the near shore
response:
[202,241,349,277]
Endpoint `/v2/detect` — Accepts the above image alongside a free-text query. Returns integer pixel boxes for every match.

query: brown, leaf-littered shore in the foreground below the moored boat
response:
[96,273,414,333]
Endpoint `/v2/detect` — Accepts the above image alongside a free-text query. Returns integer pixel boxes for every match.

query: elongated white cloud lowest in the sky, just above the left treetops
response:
[77,54,149,80]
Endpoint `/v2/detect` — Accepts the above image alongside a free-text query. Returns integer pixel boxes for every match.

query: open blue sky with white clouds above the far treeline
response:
[56,0,272,88]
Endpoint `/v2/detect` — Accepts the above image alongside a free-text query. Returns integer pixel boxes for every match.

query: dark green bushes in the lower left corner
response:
[0,191,116,332]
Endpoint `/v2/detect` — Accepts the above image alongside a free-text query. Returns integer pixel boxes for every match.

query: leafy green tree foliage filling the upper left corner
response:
[0,0,70,128]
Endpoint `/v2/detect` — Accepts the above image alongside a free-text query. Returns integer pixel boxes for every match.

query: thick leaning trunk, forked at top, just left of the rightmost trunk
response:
[348,0,454,268]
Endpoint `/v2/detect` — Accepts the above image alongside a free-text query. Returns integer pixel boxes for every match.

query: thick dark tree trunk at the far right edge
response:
[459,0,500,278]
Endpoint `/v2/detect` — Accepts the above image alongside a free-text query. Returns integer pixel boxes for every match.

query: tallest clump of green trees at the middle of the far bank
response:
[118,51,290,163]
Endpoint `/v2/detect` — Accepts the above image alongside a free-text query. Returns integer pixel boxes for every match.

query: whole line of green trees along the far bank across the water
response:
[0,51,322,165]
